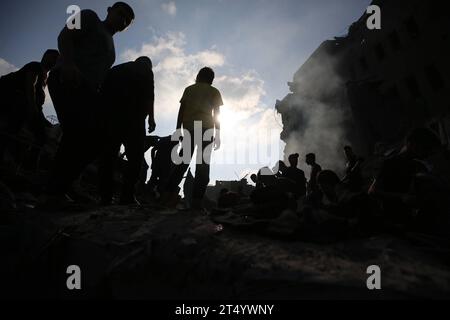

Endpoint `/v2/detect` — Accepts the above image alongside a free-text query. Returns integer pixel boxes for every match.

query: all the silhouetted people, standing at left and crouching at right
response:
[0,2,450,235]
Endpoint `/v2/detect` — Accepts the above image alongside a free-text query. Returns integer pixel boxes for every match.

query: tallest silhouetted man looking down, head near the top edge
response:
[48,2,134,200]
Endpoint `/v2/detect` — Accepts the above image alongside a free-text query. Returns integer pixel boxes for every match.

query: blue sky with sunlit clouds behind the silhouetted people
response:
[0,0,370,180]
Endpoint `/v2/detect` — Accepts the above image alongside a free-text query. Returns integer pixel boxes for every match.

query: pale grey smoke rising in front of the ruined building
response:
[282,41,351,173]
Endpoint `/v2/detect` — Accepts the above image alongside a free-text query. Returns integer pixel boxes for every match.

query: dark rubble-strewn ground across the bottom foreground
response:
[0,205,450,299]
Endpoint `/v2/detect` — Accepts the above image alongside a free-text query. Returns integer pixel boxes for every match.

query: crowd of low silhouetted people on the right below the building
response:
[246,128,450,238]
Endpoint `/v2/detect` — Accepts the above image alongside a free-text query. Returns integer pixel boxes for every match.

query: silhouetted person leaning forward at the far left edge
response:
[0,49,59,168]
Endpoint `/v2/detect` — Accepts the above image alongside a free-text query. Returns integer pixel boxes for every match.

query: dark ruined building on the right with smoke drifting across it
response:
[276,0,450,169]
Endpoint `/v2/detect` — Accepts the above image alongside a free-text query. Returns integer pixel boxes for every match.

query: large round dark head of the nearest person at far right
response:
[406,128,441,159]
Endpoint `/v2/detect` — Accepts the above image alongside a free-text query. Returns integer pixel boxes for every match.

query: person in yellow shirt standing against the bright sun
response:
[163,67,223,209]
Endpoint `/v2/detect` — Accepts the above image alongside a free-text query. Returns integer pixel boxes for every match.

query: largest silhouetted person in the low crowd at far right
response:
[369,128,439,226]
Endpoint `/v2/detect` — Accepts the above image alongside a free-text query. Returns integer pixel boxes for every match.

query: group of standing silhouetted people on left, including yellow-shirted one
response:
[0,2,223,207]
